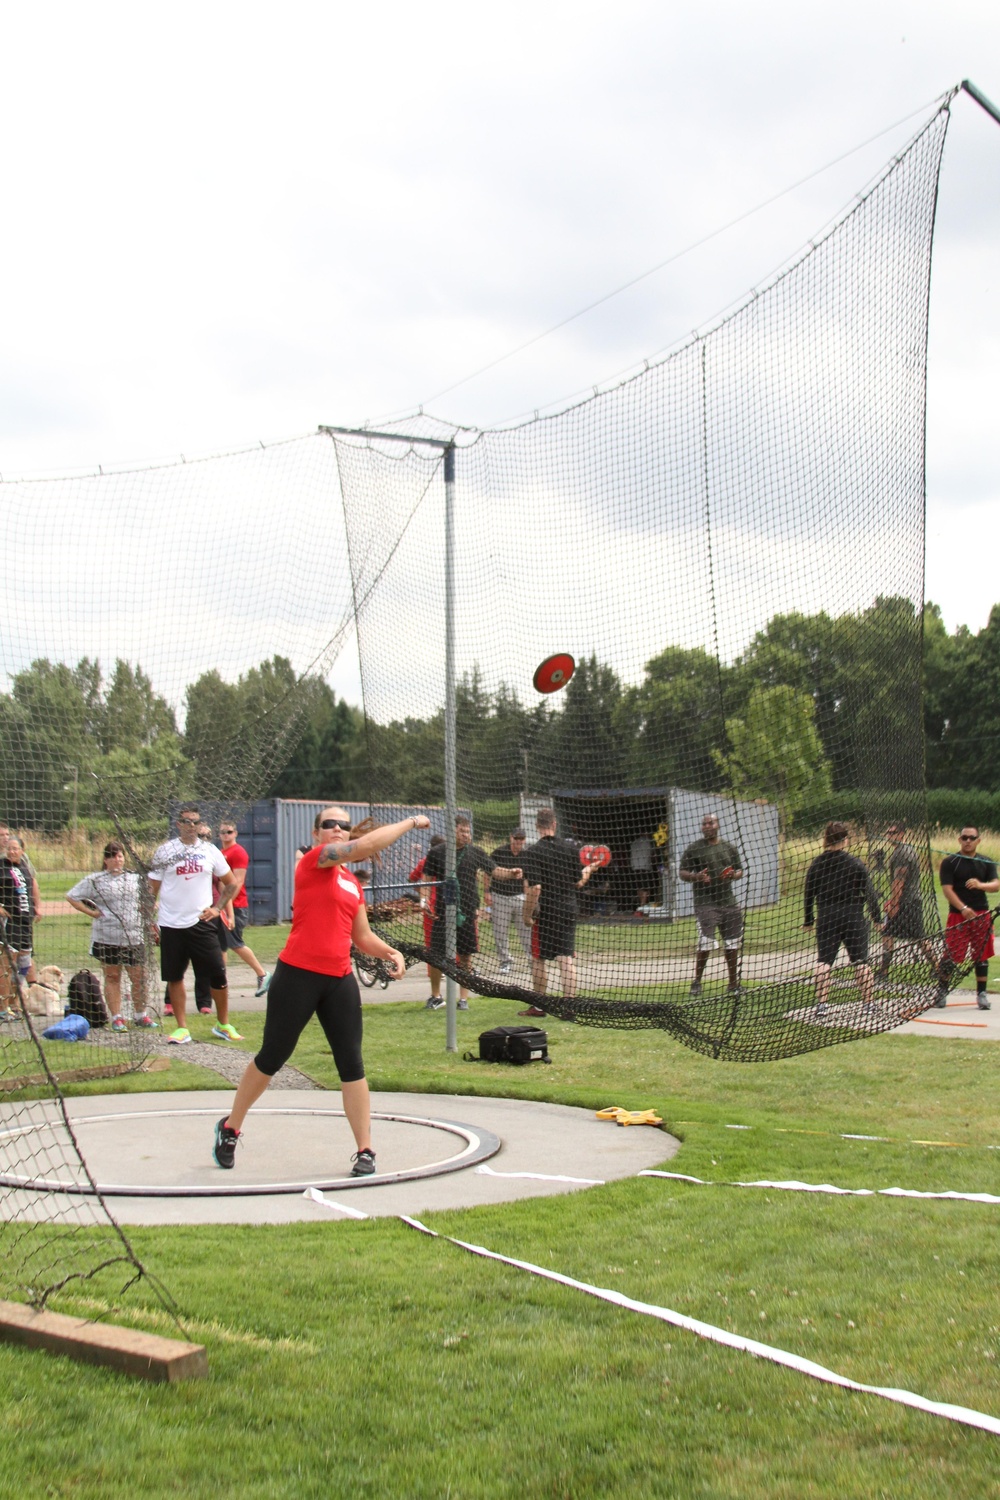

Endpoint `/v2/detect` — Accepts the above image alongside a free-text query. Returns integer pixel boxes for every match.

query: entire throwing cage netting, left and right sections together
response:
[0,96,983,1302]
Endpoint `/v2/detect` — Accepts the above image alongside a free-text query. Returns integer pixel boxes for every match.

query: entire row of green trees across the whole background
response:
[0,599,1000,828]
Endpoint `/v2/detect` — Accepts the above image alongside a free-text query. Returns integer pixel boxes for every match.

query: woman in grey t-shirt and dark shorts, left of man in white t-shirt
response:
[66,839,156,1032]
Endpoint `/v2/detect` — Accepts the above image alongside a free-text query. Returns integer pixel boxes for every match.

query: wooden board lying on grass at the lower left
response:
[0,1302,208,1382]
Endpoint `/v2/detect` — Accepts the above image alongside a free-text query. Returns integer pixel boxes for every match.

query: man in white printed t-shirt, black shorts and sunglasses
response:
[148,806,243,1046]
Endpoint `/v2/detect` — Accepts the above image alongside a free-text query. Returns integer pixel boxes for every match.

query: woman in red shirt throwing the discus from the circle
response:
[213,807,430,1178]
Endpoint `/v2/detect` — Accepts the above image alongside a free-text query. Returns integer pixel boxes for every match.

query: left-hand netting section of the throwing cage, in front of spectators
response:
[0,438,352,1307]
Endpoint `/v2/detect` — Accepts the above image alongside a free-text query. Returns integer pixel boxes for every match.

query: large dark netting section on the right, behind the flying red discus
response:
[330,101,971,1062]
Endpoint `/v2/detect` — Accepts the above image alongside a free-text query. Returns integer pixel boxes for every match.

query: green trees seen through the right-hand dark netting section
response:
[370,599,924,818]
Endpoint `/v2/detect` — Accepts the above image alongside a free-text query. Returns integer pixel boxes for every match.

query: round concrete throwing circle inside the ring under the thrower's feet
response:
[0,1101,501,1199]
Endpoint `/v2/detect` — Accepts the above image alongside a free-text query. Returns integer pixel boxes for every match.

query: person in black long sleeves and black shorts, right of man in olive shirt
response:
[802,822,882,1016]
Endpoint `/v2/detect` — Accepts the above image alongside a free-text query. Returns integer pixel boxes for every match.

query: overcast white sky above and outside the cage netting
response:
[0,0,1000,696]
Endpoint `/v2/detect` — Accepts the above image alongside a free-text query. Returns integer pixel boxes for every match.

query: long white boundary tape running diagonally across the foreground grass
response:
[400,1206,1000,1436]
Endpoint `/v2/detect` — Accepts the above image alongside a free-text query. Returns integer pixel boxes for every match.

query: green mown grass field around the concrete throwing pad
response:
[0,999,1000,1500]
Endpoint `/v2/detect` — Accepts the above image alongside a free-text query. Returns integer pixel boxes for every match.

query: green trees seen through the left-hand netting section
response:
[0,656,367,828]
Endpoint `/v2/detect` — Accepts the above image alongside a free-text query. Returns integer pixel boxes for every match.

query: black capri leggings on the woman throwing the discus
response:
[253,959,364,1083]
